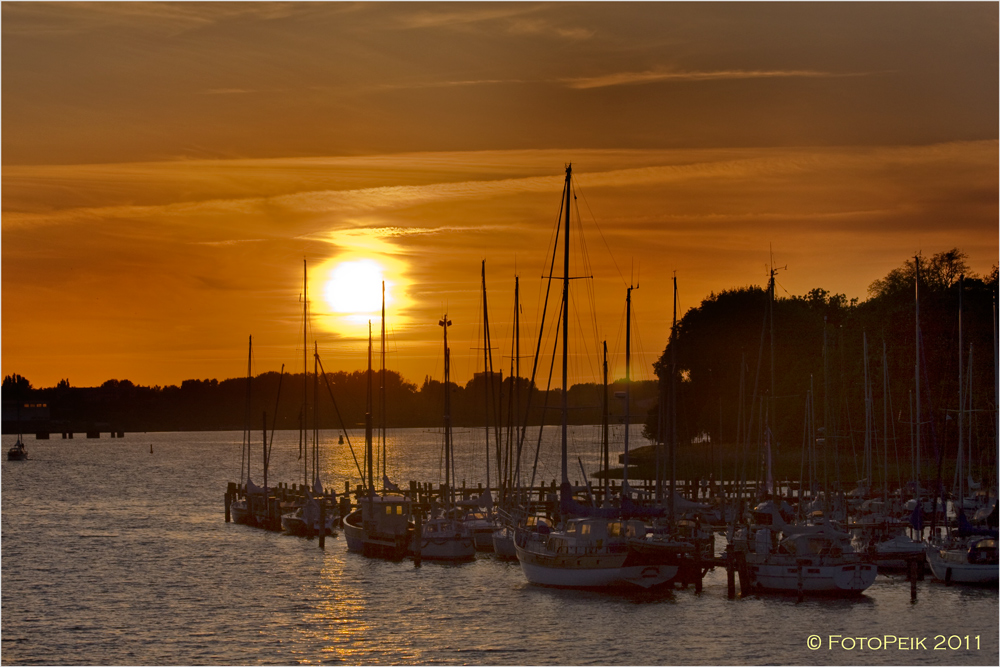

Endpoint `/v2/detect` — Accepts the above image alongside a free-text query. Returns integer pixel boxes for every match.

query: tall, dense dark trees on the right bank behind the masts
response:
[646,249,997,488]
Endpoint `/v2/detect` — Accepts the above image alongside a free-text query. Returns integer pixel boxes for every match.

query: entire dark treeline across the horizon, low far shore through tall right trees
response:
[3,249,997,477]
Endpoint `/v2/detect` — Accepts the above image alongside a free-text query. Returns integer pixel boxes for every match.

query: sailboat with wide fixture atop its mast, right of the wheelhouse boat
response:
[412,315,476,561]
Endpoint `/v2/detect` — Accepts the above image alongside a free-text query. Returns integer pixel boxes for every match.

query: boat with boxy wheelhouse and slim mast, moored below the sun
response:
[344,322,413,560]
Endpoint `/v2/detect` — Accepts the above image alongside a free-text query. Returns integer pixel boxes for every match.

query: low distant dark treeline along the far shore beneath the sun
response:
[3,370,656,432]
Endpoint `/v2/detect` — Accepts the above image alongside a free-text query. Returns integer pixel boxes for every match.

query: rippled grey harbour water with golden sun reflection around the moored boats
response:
[0,428,1000,665]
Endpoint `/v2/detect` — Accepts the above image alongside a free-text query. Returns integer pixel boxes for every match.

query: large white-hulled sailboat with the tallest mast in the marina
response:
[515,165,678,588]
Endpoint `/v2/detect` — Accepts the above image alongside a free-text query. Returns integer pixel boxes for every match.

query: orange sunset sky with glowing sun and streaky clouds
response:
[0,2,1000,387]
